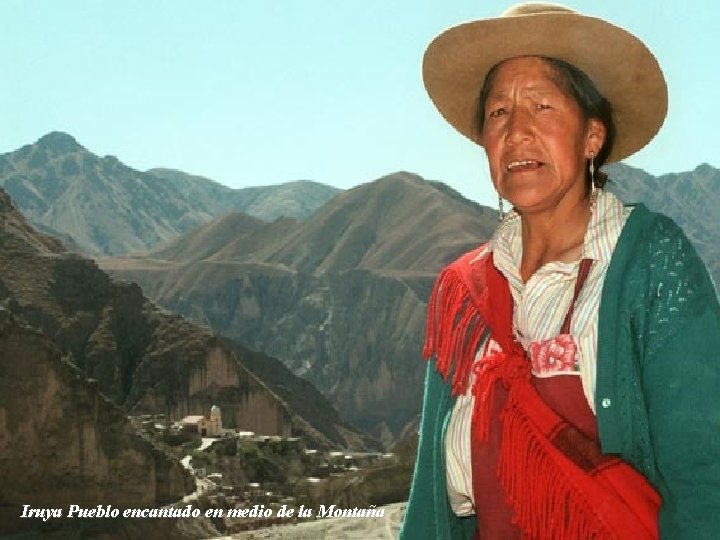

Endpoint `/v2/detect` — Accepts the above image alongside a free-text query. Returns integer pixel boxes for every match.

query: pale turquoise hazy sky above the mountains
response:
[0,0,720,205]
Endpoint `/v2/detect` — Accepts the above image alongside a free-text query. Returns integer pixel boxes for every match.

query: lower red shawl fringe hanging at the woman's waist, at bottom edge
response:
[498,380,661,540]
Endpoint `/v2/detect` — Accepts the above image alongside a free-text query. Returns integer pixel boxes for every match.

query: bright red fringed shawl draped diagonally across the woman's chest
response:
[423,245,660,540]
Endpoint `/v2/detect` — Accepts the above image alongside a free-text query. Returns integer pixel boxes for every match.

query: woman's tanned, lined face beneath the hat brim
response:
[480,56,605,213]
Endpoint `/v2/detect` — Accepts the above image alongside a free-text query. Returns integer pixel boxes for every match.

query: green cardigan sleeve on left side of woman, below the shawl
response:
[400,361,475,540]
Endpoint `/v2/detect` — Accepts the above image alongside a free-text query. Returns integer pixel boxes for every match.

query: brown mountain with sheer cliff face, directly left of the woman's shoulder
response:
[98,173,497,444]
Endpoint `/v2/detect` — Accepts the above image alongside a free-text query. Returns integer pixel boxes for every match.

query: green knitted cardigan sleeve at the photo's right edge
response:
[641,217,720,540]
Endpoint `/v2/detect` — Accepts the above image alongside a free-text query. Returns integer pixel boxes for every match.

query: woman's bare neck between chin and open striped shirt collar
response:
[520,191,594,282]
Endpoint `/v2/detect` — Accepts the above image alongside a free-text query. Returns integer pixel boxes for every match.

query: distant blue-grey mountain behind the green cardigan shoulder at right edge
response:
[607,164,720,285]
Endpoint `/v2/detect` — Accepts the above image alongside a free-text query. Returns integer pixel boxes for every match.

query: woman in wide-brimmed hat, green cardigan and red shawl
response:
[401,4,720,540]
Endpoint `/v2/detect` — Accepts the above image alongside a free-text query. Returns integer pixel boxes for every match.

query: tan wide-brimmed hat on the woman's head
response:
[423,3,667,162]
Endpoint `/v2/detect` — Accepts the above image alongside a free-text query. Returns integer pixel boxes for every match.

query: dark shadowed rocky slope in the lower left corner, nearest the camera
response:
[0,308,194,532]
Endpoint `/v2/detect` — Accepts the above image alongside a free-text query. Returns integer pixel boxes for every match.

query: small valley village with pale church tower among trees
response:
[130,405,397,534]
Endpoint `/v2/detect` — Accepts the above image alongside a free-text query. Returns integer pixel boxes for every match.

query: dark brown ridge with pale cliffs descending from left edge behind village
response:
[0,190,372,449]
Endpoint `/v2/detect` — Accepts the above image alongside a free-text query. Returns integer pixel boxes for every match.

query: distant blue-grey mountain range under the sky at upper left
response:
[0,132,339,255]
